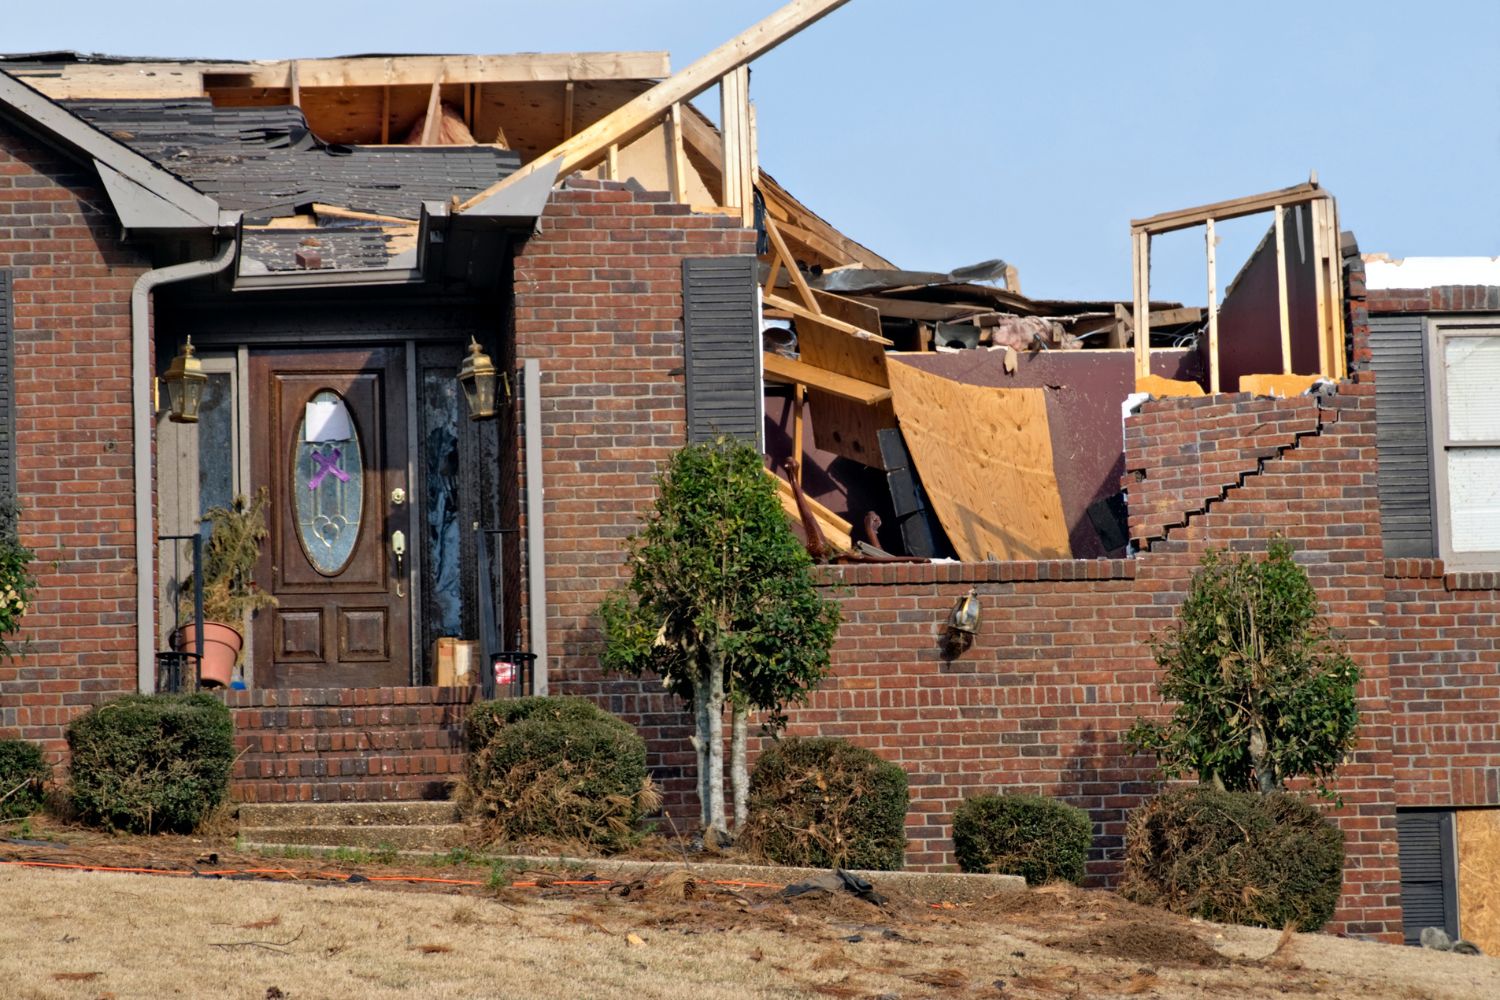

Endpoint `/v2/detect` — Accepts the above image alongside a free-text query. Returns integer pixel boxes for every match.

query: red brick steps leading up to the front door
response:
[224,688,476,802]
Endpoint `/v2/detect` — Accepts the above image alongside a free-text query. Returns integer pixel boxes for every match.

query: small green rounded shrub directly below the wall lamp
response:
[953,795,1094,886]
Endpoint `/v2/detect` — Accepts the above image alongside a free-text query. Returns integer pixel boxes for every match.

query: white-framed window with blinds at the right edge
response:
[1427,316,1500,571]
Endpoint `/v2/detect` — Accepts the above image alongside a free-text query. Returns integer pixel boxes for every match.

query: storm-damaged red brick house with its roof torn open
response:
[0,3,1500,939]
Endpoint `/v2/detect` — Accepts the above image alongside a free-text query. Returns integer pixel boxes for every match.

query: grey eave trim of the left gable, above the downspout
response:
[0,70,227,231]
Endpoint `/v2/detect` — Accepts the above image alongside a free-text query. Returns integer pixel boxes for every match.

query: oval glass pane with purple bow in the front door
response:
[291,390,365,576]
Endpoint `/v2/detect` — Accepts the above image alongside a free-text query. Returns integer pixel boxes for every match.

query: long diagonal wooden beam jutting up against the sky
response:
[459,0,849,211]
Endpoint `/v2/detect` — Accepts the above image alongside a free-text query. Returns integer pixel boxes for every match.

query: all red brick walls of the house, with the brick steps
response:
[0,111,1500,939]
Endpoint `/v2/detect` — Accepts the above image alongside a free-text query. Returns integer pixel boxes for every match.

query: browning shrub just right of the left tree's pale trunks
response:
[744,738,908,871]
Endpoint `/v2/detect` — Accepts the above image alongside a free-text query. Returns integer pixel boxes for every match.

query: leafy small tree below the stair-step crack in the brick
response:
[1127,540,1359,798]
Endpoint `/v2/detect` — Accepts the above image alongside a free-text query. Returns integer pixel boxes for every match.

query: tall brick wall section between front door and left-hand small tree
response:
[515,180,756,817]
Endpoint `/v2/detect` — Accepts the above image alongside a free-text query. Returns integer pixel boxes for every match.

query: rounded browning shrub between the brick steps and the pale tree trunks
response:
[465,697,662,850]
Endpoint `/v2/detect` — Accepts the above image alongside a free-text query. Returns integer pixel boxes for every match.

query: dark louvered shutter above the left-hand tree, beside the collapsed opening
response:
[683,256,762,444]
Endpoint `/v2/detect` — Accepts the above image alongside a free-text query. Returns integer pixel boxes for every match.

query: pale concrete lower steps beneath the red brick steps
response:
[240,801,468,853]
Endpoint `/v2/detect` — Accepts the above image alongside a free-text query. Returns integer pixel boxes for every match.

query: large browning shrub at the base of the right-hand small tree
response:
[1121,786,1344,931]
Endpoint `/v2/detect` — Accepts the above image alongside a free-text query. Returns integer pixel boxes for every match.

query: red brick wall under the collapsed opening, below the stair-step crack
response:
[792,384,1400,940]
